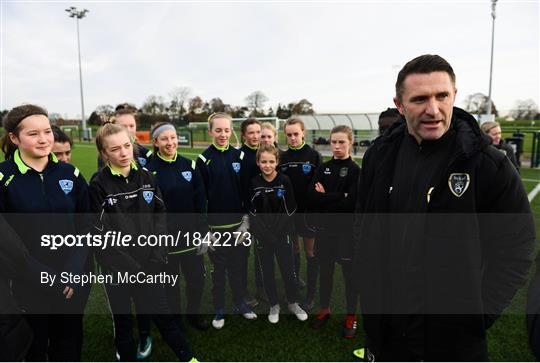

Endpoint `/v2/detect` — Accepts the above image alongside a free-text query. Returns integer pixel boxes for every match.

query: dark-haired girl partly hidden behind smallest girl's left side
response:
[240,118,264,307]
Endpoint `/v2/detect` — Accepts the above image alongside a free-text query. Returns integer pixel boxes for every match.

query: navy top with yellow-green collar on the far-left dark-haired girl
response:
[0,150,90,276]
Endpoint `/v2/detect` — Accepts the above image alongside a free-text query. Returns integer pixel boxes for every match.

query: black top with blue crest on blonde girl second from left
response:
[89,163,167,272]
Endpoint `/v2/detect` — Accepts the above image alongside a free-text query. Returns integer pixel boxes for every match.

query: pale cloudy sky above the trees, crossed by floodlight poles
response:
[0,0,540,116]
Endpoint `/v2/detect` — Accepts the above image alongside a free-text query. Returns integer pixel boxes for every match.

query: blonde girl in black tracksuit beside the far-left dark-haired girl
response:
[89,123,193,361]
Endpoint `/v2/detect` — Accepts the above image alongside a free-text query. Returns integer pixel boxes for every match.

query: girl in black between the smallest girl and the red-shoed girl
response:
[279,117,322,312]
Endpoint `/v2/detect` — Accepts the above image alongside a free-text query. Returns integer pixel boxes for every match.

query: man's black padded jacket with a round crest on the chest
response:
[354,108,535,360]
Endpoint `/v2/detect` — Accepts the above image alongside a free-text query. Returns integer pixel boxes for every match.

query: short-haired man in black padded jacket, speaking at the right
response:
[354,55,535,361]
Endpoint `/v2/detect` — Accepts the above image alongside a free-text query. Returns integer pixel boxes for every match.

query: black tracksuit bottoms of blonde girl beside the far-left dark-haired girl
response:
[105,284,193,361]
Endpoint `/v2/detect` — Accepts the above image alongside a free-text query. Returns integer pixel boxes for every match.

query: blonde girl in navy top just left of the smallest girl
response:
[197,113,257,329]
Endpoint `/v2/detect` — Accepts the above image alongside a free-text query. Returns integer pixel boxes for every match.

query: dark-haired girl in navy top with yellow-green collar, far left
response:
[0,105,89,361]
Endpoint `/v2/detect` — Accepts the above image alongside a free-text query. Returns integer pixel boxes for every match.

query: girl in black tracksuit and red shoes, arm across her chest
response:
[308,126,360,338]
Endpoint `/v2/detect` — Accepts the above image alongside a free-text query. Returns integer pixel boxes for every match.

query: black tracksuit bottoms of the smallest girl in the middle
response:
[257,236,297,306]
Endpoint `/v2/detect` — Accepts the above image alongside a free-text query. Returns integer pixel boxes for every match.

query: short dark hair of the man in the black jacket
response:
[396,54,456,101]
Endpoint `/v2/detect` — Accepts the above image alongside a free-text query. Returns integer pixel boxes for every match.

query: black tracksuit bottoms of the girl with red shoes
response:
[315,233,358,314]
